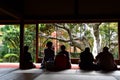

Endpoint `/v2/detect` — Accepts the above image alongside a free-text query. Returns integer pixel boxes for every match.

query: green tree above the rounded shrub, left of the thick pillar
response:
[0,25,20,55]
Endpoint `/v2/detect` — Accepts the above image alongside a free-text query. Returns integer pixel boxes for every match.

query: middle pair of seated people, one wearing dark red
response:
[41,42,71,70]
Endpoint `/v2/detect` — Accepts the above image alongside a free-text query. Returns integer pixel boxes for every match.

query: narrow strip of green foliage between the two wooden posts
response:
[24,24,36,61]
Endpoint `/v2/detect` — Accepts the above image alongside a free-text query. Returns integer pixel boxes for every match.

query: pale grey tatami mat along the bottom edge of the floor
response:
[35,74,116,80]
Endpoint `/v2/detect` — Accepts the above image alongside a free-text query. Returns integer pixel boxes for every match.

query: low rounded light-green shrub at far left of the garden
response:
[3,53,19,62]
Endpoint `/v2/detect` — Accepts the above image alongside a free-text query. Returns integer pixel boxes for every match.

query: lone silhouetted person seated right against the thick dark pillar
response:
[24,46,36,69]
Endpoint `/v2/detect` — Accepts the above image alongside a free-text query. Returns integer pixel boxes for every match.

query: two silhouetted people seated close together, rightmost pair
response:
[79,47,117,71]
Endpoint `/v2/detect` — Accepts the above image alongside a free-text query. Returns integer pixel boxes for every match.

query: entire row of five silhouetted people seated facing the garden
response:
[24,41,117,70]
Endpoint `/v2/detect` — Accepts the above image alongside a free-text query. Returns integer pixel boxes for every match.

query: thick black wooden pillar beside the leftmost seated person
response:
[19,21,24,69]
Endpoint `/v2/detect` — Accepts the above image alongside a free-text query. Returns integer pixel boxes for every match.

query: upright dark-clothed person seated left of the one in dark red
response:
[41,41,55,69]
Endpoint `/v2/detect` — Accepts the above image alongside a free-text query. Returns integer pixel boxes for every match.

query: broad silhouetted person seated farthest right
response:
[96,47,117,70]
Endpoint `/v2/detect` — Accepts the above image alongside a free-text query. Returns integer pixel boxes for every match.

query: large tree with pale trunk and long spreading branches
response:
[39,22,118,56]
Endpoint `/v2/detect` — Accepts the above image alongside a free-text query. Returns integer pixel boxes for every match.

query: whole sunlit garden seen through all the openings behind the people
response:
[0,22,119,62]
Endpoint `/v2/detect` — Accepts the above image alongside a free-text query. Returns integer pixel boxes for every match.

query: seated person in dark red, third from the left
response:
[55,45,71,70]
